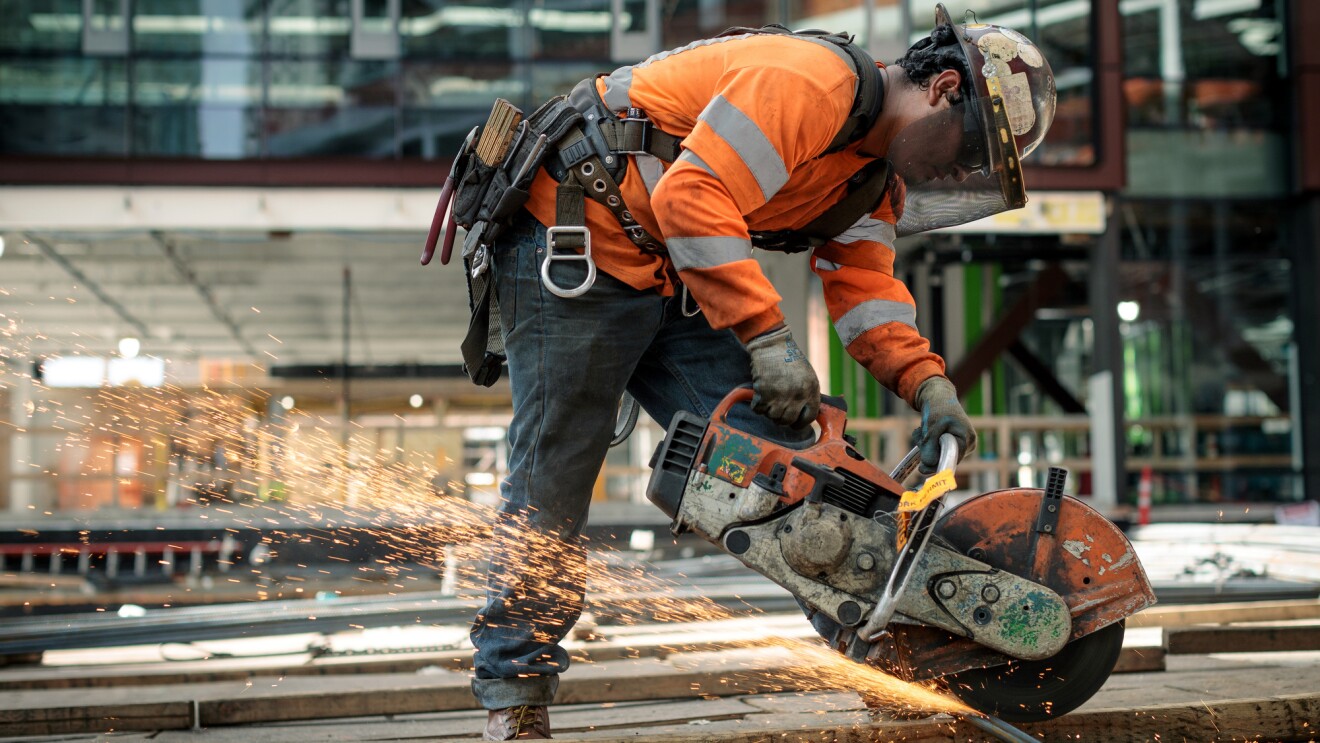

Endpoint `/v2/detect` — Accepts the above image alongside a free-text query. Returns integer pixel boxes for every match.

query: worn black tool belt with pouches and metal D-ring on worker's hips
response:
[451,79,680,387]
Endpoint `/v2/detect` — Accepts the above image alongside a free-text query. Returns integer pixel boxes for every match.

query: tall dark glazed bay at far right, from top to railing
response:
[1121,0,1313,503]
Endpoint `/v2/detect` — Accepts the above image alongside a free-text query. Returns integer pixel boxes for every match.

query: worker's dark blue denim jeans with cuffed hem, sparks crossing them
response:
[471,214,834,710]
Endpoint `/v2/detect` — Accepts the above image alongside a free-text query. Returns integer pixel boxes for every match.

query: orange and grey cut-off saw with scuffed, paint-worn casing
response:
[647,388,1155,722]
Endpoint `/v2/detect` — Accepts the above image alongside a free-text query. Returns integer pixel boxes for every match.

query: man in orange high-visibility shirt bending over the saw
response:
[459,7,1055,740]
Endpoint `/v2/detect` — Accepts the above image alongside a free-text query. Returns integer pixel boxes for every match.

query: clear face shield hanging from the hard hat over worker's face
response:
[888,95,1027,236]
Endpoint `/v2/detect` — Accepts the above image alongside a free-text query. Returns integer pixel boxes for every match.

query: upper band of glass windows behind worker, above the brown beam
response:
[0,0,1094,165]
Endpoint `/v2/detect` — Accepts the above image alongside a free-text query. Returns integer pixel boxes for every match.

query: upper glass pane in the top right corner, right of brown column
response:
[1123,0,1291,198]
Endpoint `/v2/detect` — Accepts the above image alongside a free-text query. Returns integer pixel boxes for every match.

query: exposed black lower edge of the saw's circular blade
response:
[944,622,1125,722]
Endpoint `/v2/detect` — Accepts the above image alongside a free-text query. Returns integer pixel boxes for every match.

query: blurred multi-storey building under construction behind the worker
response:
[0,0,1320,567]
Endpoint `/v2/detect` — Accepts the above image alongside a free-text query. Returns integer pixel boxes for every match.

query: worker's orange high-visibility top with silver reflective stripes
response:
[527,34,944,404]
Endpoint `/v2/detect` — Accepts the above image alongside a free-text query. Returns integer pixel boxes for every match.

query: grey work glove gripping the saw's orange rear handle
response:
[747,326,821,429]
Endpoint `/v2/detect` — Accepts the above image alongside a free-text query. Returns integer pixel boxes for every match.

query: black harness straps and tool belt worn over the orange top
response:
[446,24,891,387]
